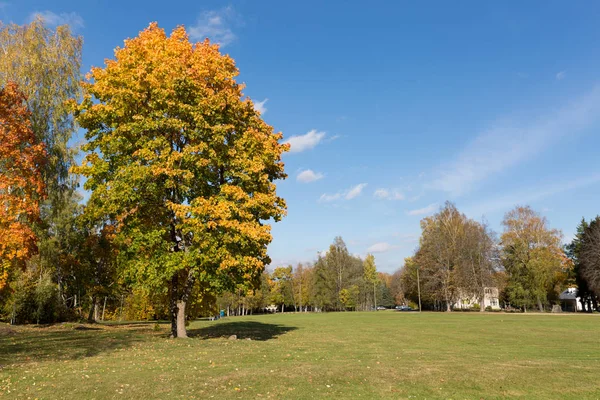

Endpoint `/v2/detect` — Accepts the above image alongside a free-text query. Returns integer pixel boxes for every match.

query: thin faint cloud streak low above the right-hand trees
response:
[465,173,600,217]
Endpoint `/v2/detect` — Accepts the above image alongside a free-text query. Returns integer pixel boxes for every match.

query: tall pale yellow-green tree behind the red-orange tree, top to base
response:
[0,18,83,322]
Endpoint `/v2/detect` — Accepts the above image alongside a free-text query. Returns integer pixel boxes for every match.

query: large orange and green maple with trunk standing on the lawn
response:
[76,23,288,337]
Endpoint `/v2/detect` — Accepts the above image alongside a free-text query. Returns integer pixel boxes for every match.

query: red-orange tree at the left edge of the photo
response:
[0,82,46,289]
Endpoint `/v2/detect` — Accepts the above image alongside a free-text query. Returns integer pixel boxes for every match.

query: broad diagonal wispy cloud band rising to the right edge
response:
[426,87,600,196]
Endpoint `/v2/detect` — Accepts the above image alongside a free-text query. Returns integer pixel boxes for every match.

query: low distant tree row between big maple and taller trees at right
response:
[217,237,403,315]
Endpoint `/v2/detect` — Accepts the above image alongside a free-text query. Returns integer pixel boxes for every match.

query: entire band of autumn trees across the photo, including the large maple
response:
[0,19,600,337]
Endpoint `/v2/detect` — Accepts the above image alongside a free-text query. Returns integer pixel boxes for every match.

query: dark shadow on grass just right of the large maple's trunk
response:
[188,321,298,341]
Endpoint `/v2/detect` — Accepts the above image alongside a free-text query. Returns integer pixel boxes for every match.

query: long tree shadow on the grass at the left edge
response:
[0,325,150,365]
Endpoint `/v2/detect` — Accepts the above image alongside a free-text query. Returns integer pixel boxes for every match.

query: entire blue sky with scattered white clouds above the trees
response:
[0,0,600,272]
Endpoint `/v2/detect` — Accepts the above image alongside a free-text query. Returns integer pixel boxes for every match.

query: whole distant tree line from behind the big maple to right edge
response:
[217,202,600,315]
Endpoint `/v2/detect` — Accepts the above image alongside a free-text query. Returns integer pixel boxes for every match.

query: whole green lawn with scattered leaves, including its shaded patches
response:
[0,311,600,399]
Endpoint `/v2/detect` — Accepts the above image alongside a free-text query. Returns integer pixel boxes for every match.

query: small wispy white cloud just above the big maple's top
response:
[189,6,239,47]
